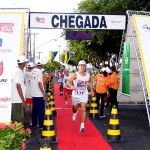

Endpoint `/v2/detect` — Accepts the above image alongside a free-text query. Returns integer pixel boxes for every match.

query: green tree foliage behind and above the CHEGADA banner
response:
[65,0,150,68]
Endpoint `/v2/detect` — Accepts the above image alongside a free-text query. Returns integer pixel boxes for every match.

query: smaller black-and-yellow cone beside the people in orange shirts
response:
[89,96,99,119]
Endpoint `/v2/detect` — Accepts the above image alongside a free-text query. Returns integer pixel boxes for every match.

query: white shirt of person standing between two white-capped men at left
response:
[25,72,32,98]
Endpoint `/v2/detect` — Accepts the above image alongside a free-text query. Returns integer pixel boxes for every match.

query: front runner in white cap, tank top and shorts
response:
[67,60,94,132]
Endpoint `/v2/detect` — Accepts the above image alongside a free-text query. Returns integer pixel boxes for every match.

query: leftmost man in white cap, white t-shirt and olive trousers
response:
[11,56,28,123]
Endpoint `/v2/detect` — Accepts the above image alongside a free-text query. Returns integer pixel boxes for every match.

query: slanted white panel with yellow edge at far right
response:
[133,15,150,97]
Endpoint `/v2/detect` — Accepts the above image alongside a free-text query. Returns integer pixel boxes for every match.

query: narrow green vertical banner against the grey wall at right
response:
[122,42,130,95]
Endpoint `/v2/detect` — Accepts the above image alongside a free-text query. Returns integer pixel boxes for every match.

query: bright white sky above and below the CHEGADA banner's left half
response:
[0,0,81,61]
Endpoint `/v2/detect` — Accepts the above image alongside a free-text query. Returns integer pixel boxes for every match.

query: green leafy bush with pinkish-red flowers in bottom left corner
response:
[0,122,31,150]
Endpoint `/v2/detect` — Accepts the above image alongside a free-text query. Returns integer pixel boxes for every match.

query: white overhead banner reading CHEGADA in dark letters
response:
[30,12,126,30]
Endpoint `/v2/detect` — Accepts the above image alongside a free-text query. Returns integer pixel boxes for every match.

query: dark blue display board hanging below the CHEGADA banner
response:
[66,31,92,40]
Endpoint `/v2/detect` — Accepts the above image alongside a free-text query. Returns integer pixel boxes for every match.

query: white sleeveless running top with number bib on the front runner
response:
[72,72,90,97]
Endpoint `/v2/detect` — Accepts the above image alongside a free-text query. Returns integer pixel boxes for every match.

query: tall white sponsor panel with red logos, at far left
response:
[0,11,25,123]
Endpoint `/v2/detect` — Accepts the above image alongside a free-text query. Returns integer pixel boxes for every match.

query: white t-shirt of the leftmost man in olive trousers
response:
[11,68,26,103]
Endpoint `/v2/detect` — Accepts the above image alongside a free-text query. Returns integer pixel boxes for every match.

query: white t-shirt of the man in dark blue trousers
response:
[31,68,44,97]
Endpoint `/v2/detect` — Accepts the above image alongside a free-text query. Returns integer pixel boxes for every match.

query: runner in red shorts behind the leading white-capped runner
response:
[63,69,72,105]
